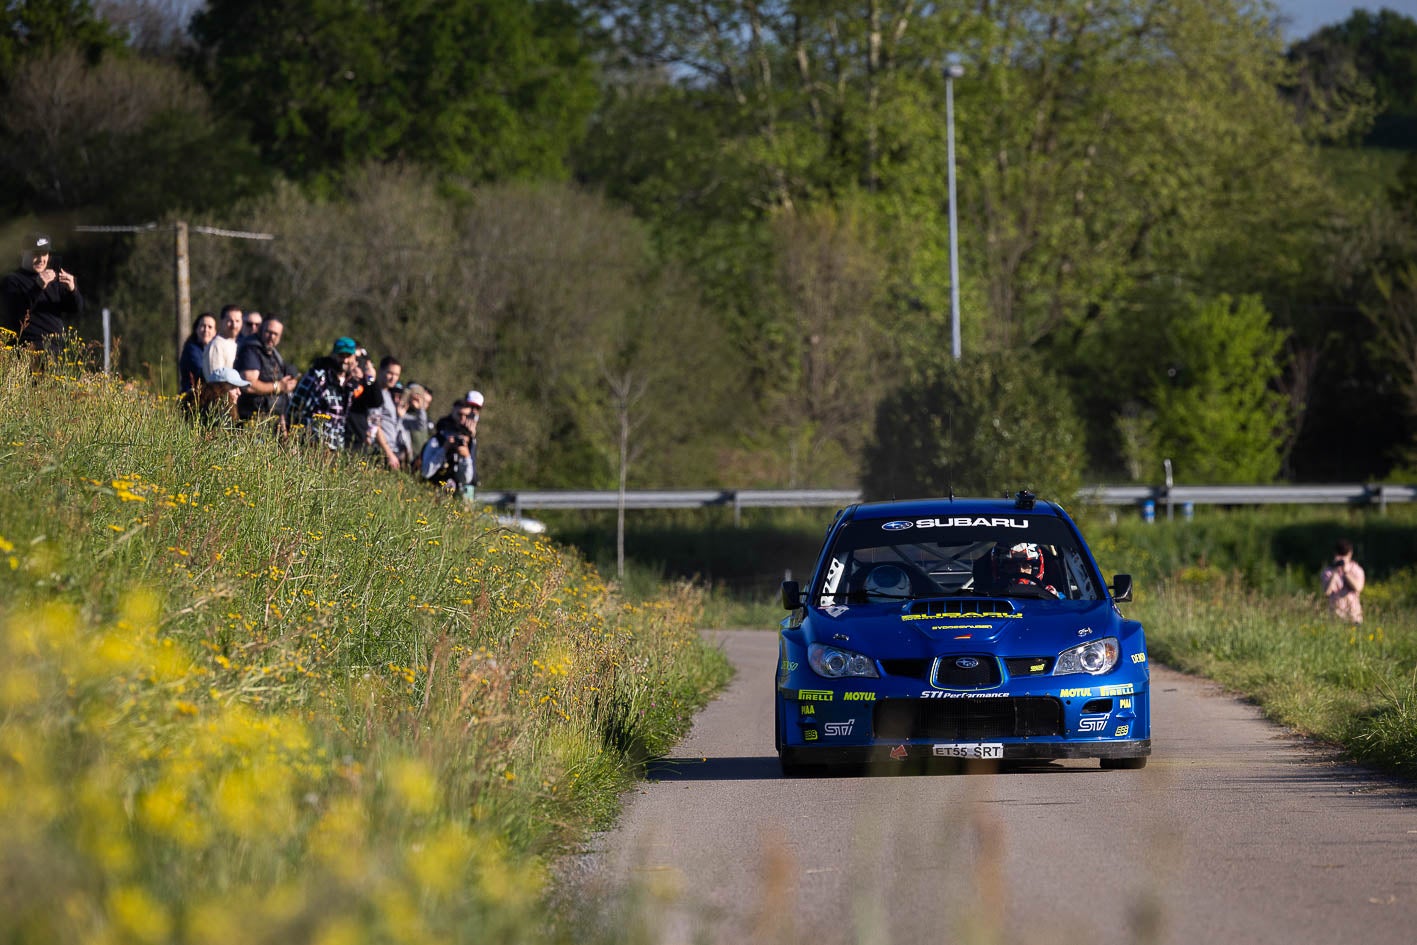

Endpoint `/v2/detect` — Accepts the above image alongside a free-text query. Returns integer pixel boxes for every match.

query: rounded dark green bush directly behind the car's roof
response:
[862,354,1083,500]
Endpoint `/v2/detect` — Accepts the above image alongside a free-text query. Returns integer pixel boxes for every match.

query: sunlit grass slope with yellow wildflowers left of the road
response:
[0,350,728,945]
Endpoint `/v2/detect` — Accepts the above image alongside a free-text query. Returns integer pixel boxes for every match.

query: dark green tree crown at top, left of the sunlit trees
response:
[193,0,594,189]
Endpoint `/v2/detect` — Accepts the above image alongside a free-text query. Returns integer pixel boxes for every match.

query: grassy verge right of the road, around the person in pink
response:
[1084,506,1417,778]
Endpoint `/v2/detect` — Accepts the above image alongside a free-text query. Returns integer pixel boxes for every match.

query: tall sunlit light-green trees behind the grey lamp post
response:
[581,0,1337,481]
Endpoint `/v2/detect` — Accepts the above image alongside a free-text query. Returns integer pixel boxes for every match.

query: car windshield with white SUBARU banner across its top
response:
[813,513,1102,606]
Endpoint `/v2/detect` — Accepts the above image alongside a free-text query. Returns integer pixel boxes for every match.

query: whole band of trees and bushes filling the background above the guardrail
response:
[0,0,1417,494]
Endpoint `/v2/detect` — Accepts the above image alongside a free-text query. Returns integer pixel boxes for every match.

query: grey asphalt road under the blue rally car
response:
[565,630,1417,945]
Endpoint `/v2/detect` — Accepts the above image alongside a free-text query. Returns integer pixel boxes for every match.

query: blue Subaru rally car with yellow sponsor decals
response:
[775,492,1151,774]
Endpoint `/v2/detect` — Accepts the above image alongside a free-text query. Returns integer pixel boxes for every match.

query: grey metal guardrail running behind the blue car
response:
[478,483,1417,521]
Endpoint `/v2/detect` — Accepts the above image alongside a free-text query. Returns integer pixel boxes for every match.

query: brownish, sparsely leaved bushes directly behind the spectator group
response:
[107,172,741,489]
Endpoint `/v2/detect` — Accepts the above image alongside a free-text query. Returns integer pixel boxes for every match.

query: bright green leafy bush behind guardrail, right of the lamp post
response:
[1151,296,1288,483]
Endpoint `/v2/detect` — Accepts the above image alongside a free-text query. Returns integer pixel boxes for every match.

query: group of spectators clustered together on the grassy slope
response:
[177,305,483,502]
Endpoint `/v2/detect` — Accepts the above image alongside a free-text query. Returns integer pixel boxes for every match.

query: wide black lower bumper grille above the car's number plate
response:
[871,696,1063,741]
